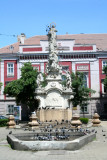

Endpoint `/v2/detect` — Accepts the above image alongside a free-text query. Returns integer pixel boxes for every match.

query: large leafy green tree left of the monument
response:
[4,63,38,111]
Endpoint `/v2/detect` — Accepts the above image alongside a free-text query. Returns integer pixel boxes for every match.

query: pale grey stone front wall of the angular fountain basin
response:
[7,133,96,151]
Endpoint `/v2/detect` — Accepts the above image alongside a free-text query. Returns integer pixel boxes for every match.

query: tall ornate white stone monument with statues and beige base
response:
[36,24,72,121]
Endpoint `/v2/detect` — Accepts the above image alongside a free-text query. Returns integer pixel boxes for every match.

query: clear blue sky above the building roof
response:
[0,0,107,48]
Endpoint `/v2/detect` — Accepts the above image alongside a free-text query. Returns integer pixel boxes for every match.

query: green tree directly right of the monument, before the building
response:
[71,72,95,112]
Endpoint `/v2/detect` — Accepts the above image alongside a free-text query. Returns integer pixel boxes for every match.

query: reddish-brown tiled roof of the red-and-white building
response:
[0,33,107,54]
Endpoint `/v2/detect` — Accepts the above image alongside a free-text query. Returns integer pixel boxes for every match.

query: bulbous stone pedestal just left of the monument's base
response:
[28,114,39,130]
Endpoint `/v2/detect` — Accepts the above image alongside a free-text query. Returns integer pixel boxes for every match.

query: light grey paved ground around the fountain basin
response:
[0,121,107,160]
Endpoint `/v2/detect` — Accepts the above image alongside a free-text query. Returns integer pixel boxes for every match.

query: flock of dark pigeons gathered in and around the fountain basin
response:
[9,120,106,141]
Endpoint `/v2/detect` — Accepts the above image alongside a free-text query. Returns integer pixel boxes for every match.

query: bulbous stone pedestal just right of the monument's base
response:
[71,114,82,128]
